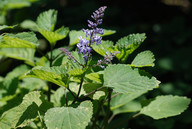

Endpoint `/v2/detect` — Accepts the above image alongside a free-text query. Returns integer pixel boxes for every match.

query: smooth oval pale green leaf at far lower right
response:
[140,95,191,119]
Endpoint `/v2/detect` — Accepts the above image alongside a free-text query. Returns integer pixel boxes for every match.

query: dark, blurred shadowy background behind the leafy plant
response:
[1,0,192,129]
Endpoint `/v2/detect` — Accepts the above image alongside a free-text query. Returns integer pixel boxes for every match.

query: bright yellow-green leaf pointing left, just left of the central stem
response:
[23,66,68,86]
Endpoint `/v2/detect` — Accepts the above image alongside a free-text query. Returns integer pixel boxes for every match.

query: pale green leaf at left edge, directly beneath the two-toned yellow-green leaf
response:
[0,48,35,64]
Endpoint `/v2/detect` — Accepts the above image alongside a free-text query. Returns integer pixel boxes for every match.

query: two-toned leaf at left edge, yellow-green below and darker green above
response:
[0,32,39,48]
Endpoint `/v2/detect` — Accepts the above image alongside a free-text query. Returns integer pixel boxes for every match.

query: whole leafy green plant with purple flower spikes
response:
[0,6,190,129]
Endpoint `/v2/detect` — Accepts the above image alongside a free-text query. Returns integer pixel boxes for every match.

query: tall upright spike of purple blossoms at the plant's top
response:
[77,6,107,62]
